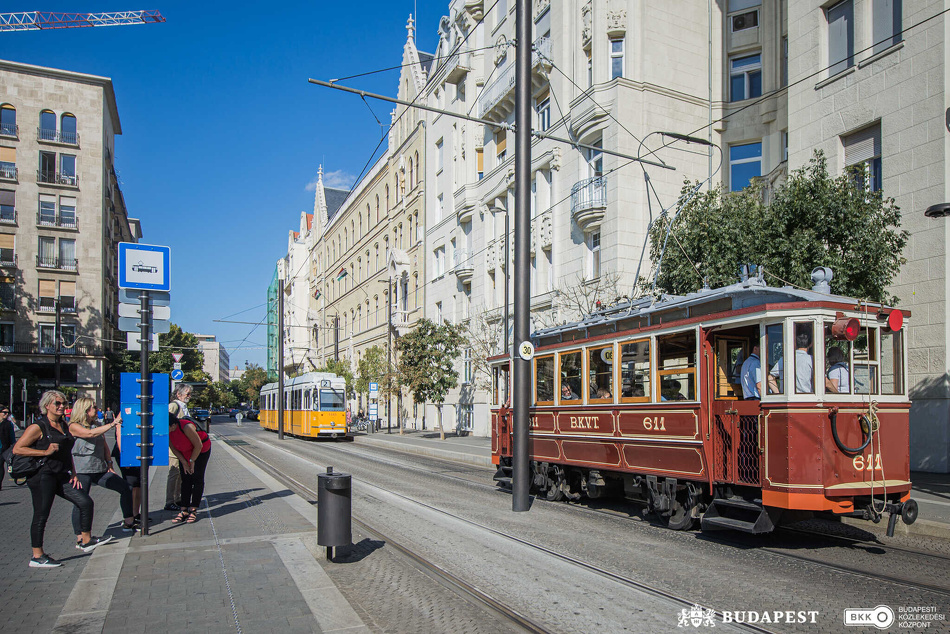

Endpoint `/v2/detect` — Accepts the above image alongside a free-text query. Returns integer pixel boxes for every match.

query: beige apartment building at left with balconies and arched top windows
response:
[0,61,141,404]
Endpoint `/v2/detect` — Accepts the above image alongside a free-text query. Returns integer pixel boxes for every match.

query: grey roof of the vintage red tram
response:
[531,277,896,340]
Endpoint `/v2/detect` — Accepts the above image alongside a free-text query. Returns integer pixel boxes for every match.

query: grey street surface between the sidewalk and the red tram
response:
[219,420,950,632]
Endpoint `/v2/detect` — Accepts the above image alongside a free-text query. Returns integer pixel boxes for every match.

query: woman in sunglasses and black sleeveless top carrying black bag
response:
[13,390,112,568]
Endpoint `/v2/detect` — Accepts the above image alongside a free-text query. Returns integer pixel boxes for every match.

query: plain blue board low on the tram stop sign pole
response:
[119,372,170,467]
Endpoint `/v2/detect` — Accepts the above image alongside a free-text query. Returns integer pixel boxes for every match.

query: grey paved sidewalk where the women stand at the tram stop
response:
[0,439,368,634]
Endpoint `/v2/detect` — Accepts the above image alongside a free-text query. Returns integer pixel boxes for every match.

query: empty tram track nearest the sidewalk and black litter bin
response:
[225,424,775,634]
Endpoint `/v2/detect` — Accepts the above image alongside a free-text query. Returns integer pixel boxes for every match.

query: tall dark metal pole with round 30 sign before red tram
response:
[505,0,532,512]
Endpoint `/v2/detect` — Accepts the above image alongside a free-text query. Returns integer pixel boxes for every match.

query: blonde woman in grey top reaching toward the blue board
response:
[69,398,136,541]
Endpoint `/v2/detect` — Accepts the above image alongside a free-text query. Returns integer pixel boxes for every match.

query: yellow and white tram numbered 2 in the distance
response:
[260,372,353,440]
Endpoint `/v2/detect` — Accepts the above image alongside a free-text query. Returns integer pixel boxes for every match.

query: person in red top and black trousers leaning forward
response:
[168,403,211,524]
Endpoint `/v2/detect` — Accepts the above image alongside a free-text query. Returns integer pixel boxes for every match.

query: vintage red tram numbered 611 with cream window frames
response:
[491,275,917,534]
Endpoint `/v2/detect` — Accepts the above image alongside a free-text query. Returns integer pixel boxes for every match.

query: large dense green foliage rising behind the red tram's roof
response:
[640,152,908,304]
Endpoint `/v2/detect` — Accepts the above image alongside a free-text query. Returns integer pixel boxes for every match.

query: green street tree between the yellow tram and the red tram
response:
[396,318,465,440]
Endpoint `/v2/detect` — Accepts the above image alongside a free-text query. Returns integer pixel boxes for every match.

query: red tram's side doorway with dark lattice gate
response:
[707,327,764,486]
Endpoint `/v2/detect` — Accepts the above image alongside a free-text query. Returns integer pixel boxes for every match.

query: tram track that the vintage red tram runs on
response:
[256,428,950,598]
